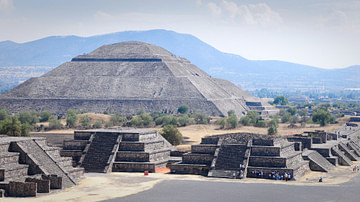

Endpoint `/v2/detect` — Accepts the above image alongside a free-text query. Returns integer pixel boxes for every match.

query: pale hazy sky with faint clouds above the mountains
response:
[0,0,360,68]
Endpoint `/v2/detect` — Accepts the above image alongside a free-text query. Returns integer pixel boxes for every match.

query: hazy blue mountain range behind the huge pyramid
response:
[0,30,360,92]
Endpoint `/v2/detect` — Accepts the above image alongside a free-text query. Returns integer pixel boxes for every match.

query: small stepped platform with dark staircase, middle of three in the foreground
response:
[61,128,174,173]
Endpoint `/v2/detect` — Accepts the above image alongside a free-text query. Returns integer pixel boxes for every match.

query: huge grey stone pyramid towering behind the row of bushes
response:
[0,42,276,116]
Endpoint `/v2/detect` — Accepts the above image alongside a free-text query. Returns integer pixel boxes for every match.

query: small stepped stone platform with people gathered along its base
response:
[170,133,309,179]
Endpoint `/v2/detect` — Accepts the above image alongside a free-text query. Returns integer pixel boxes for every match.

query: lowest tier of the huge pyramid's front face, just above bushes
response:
[0,99,222,116]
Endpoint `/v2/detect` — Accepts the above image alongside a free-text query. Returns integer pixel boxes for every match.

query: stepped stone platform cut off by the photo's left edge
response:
[0,136,84,196]
